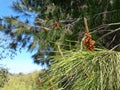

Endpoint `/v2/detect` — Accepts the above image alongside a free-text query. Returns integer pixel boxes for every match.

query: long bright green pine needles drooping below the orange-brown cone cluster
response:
[41,50,120,90]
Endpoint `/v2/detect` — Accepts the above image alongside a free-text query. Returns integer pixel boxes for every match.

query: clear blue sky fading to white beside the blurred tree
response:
[0,0,42,73]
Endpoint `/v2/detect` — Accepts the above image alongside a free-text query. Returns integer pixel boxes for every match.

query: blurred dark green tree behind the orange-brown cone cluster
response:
[1,0,120,64]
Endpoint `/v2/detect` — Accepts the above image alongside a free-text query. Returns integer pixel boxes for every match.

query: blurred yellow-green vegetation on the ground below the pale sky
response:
[2,71,39,90]
